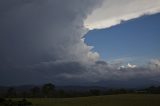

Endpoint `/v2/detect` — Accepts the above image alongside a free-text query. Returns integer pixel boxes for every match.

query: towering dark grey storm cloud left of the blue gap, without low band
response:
[0,0,101,84]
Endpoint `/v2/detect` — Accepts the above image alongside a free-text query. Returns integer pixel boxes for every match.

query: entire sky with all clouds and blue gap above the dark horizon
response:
[0,0,160,87]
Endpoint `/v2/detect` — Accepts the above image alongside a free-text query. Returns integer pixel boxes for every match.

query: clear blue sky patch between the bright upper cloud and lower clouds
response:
[85,14,160,65]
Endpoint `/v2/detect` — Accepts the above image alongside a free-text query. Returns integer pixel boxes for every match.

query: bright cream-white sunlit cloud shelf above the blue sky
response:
[85,0,160,30]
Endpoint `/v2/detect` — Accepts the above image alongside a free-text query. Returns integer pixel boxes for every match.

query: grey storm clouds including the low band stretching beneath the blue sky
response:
[0,0,160,85]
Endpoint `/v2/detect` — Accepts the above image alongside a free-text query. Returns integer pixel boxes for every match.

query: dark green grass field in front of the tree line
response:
[14,94,160,106]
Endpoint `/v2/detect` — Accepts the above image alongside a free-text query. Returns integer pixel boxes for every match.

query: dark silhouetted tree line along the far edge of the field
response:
[0,83,160,98]
